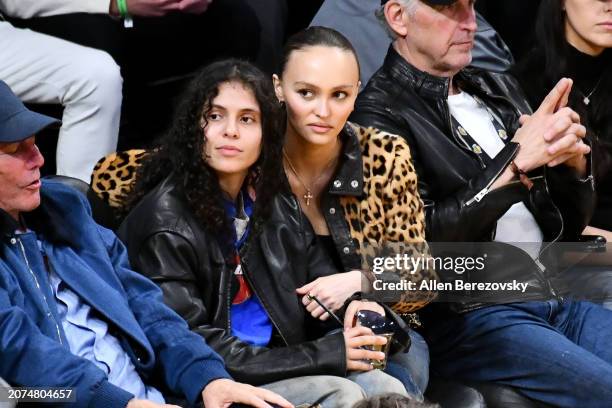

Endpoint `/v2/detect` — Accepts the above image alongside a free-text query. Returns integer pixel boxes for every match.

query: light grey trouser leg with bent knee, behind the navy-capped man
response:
[0,16,122,183]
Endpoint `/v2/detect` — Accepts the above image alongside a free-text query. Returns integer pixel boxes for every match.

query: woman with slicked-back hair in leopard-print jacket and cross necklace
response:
[273,27,432,399]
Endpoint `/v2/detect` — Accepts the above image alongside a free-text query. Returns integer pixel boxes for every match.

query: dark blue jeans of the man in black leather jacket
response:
[425,300,612,408]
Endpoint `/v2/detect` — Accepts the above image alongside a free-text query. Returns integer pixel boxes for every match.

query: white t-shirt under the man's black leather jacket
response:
[448,92,544,259]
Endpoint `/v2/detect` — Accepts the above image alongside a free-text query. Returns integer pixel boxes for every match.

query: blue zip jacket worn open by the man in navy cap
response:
[0,179,230,408]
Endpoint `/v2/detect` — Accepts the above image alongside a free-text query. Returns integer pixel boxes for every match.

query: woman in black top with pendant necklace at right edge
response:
[515,0,612,236]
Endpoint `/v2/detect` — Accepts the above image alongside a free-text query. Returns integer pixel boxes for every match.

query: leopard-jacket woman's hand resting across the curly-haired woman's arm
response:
[296,271,362,320]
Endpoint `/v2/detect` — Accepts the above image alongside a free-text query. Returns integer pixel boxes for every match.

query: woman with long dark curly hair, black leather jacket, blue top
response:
[119,60,403,407]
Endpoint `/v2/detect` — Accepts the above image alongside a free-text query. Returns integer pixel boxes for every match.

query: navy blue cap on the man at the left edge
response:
[0,81,60,143]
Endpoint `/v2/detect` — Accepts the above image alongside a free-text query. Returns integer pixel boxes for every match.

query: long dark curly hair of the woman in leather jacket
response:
[125,59,283,241]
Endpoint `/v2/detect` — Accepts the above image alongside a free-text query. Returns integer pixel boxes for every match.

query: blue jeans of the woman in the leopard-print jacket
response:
[385,330,429,401]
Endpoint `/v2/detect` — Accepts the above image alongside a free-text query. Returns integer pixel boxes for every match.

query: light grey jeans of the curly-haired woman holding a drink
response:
[261,370,406,408]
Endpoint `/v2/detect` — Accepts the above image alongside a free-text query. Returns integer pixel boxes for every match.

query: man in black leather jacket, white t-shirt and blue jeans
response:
[351,0,612,407]
